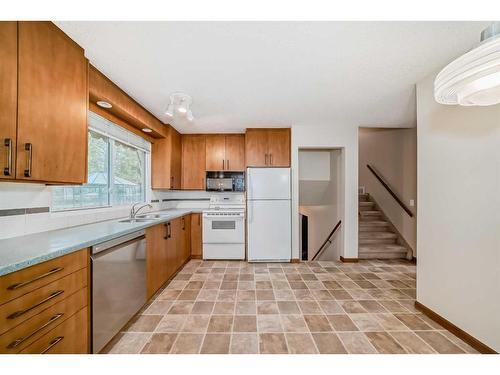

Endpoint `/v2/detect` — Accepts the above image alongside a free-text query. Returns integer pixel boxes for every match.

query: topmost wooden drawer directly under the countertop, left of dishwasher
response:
[0,249,89,305]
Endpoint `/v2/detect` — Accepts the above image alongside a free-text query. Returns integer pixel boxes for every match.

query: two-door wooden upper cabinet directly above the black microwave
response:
[206,134,245,171]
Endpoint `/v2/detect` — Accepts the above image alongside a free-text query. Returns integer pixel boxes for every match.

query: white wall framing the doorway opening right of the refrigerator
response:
[292,125,358,258]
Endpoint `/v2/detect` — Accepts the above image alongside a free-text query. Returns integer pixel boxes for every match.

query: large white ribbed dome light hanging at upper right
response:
[434,22,500,106]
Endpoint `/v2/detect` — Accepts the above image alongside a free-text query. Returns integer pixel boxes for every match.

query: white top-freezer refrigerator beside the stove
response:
[246,168,292,262]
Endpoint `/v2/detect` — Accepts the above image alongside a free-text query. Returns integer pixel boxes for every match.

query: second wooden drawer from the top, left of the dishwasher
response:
[0,268,87,334]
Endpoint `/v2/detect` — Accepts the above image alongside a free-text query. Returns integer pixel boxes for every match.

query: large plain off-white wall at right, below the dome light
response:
[417,72,500,351]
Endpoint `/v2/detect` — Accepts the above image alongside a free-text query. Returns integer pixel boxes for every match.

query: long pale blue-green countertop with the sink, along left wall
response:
[0,208,202,276]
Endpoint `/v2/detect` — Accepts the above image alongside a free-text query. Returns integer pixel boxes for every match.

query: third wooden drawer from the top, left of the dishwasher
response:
[0,288,88,354]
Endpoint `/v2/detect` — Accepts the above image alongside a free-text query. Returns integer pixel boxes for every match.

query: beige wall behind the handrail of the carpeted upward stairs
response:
[358,128,417,256]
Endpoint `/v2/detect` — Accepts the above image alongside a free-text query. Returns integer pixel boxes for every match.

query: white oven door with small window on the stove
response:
[203,214,245,244]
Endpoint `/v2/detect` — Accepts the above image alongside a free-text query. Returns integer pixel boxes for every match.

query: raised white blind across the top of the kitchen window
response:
[88,112,151,152]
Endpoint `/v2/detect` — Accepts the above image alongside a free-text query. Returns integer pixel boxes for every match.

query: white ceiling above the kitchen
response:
[56,21,488,133]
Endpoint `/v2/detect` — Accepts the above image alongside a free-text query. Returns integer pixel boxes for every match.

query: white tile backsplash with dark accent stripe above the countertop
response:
[0,182,241,239]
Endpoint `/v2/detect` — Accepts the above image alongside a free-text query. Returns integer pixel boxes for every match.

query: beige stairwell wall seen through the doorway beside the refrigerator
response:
[299,150,344,260]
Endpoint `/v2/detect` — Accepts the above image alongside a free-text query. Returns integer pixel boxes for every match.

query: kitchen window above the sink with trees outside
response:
[52,113,151,211]
